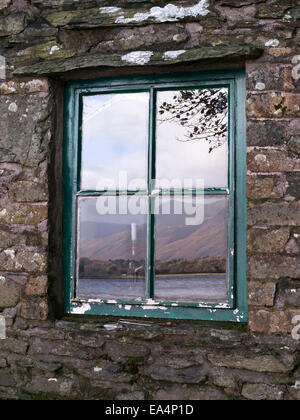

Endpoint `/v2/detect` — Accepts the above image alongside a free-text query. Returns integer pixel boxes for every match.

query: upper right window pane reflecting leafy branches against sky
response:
[156,88,228,188]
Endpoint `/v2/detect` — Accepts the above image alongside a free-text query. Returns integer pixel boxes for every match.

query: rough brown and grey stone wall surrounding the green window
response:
[0,0,300,400]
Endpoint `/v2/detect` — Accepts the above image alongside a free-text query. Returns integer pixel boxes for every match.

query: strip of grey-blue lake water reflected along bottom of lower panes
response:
[77,274,228,301]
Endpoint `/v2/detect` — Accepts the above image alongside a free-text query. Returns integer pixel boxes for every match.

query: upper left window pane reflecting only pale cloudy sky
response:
[81,92,149,190]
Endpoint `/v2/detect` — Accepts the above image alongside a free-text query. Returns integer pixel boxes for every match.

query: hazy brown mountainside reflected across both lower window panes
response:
[80,199,228,261]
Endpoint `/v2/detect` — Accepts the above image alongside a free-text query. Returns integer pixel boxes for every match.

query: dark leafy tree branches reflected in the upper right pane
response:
[159,89,228,152]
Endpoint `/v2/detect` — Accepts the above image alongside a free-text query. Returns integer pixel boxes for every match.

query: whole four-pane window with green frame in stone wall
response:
[63,70,247,322]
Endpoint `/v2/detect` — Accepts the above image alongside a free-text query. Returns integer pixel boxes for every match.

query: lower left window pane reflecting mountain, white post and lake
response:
[77,196,148,299]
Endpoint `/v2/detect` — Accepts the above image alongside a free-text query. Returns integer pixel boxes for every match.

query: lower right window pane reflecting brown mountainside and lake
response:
[155,196,229,301]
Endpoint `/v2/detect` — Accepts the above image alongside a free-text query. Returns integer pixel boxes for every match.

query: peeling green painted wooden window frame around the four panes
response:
[63,69,248,322]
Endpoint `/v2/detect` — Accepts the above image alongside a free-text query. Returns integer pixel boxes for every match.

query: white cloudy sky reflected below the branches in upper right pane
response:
[156,91,228,188]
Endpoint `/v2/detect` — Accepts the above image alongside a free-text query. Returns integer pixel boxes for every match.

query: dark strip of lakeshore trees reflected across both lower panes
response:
[79,257,226,278]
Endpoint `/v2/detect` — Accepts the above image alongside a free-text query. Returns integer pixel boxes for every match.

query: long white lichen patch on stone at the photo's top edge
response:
[116,0,209,24]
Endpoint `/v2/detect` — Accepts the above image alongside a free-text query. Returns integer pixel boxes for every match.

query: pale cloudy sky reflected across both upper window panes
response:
[81,91,228,190]
